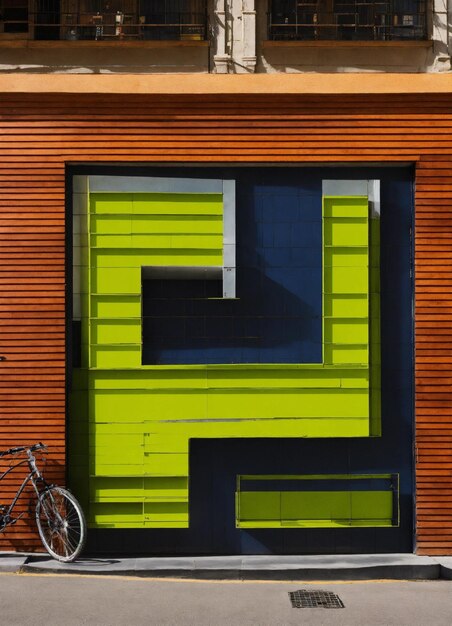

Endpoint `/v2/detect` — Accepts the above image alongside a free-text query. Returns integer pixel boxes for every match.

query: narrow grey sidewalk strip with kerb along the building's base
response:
[0,553,452,581]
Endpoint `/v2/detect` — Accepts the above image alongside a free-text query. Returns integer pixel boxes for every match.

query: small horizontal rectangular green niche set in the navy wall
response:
[236,474,399,528]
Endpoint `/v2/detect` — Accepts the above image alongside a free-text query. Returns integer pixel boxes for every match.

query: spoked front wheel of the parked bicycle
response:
[36,487,86,563]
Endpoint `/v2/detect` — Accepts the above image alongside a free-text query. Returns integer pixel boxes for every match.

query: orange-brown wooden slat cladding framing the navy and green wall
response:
[0,91,452,554]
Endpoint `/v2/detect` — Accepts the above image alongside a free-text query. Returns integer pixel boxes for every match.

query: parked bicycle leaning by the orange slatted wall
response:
[0,443,86,563]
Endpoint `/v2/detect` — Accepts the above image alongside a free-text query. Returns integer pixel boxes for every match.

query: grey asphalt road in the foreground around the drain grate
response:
[0,574,452,626]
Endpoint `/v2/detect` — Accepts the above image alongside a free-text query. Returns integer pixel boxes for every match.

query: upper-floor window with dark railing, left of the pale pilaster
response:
[0,0,207,41]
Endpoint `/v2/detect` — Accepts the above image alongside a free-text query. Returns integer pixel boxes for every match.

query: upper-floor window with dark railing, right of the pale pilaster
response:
[269,0,427,41]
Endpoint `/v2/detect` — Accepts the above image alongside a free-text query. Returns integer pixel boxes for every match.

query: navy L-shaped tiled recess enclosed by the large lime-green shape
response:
[143,170,322,365]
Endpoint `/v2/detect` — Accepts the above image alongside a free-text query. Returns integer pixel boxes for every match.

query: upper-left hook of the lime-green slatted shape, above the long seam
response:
[82,193,223,370]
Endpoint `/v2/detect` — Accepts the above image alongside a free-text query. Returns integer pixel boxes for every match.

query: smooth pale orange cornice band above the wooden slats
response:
[0,73,452,95]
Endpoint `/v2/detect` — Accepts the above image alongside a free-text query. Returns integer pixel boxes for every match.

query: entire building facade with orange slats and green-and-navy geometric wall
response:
[0,0,452,554]
